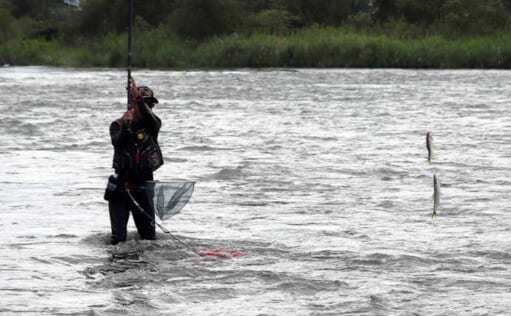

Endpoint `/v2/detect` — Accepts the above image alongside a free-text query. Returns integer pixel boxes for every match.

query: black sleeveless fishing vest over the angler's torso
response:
[113,120,163,180]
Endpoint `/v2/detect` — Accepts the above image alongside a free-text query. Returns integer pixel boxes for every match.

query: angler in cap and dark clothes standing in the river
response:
[105,79,163,245]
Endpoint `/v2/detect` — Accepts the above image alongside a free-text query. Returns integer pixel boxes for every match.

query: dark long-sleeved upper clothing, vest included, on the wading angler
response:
[110,101,163,183]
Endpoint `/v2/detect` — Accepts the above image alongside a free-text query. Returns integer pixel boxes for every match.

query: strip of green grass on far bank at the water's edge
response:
[0,27,511,69]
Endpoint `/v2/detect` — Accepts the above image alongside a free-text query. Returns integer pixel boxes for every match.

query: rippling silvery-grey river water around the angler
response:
[0,67,511,315]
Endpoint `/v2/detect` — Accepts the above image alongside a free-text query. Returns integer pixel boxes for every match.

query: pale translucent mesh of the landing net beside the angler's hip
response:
[153,182,195,221]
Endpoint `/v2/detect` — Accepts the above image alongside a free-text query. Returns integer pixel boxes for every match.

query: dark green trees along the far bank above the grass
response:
[0,0,511,44]
